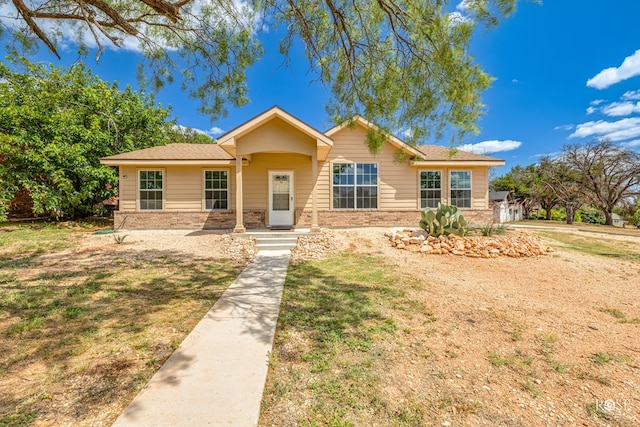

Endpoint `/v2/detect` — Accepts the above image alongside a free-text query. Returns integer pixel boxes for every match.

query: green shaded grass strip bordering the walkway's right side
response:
[262,253,435,426]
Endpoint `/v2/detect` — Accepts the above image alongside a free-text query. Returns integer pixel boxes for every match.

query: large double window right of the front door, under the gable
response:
[333,163,378,209]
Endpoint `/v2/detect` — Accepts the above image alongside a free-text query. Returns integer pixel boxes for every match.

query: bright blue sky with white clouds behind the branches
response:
[1,0,640,175]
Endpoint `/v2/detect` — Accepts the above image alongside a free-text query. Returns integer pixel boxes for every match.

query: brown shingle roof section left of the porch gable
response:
[103,143,233,160]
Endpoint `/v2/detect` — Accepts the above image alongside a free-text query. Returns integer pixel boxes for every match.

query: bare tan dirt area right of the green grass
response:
[288,229,640,426]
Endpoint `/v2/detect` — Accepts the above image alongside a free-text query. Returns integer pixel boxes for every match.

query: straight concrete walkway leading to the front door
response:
[113,251,290,427]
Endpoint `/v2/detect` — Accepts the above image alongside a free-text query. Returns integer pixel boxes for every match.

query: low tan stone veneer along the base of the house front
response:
[113,209,493,229]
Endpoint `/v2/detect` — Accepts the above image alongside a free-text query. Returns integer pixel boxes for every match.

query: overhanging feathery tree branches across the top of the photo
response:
[0,0,520,147]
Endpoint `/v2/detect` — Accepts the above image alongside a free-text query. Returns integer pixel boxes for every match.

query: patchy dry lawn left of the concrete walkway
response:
[0,227,242,426]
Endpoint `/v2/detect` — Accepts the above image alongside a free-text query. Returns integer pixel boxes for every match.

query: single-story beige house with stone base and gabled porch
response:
[101,107,504,232]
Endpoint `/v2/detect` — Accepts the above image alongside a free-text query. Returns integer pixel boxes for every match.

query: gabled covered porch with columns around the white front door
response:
[218,107,333,233]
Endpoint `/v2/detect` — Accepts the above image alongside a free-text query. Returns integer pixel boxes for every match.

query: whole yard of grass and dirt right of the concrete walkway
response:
[259,234,640,427]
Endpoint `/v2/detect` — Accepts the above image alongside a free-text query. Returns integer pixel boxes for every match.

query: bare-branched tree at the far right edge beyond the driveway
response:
[562,139,640,225]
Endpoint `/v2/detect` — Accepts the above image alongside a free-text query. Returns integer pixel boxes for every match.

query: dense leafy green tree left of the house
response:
[0,56,173,220]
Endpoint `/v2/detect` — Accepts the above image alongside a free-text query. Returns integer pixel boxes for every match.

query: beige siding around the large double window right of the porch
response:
[318,126,418,210]
